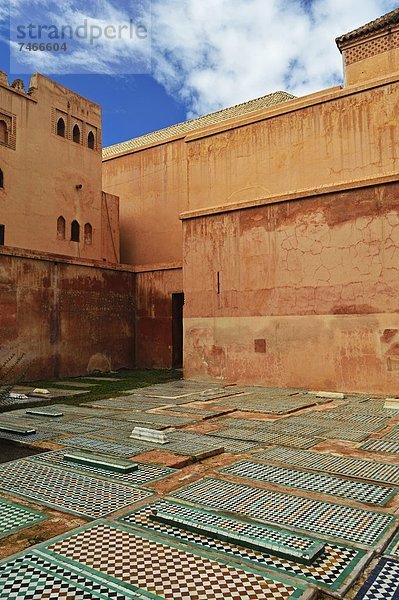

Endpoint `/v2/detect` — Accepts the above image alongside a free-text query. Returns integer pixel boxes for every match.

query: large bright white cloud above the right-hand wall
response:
[153,0,398,116]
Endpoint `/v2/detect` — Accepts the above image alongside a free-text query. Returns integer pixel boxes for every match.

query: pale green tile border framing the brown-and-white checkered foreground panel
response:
[39,519,309,598]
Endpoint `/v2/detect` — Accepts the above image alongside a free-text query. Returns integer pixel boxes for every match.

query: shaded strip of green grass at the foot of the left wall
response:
[0,369,182,410]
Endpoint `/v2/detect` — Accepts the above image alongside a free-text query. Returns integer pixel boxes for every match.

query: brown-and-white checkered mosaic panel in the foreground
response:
[44,522,303,600]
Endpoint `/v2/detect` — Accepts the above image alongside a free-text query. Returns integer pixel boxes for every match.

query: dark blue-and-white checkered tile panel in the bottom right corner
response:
[355,558,399,600]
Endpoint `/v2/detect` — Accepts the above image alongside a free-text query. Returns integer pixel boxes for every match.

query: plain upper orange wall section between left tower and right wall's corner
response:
[103,140,187,265]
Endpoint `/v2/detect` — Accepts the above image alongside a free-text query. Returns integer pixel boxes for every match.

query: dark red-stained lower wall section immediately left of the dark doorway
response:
[136,268,183,368]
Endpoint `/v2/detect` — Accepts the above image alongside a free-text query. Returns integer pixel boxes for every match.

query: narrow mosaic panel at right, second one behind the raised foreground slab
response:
[221,460,398,506]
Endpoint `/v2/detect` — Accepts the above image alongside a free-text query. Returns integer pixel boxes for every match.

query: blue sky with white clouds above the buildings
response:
[0,0,399,145]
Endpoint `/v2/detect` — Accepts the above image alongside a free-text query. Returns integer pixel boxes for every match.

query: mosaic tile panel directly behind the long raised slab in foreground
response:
[172,478,396,546]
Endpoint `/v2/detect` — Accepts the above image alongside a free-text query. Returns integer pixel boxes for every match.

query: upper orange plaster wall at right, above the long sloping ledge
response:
[187,82,399,211]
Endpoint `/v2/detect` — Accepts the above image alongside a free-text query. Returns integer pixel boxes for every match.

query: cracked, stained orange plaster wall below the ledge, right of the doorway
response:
[184,184,399,394]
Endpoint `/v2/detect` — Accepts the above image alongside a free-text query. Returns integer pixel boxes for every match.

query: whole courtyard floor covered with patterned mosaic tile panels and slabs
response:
[0,378,399,600]
